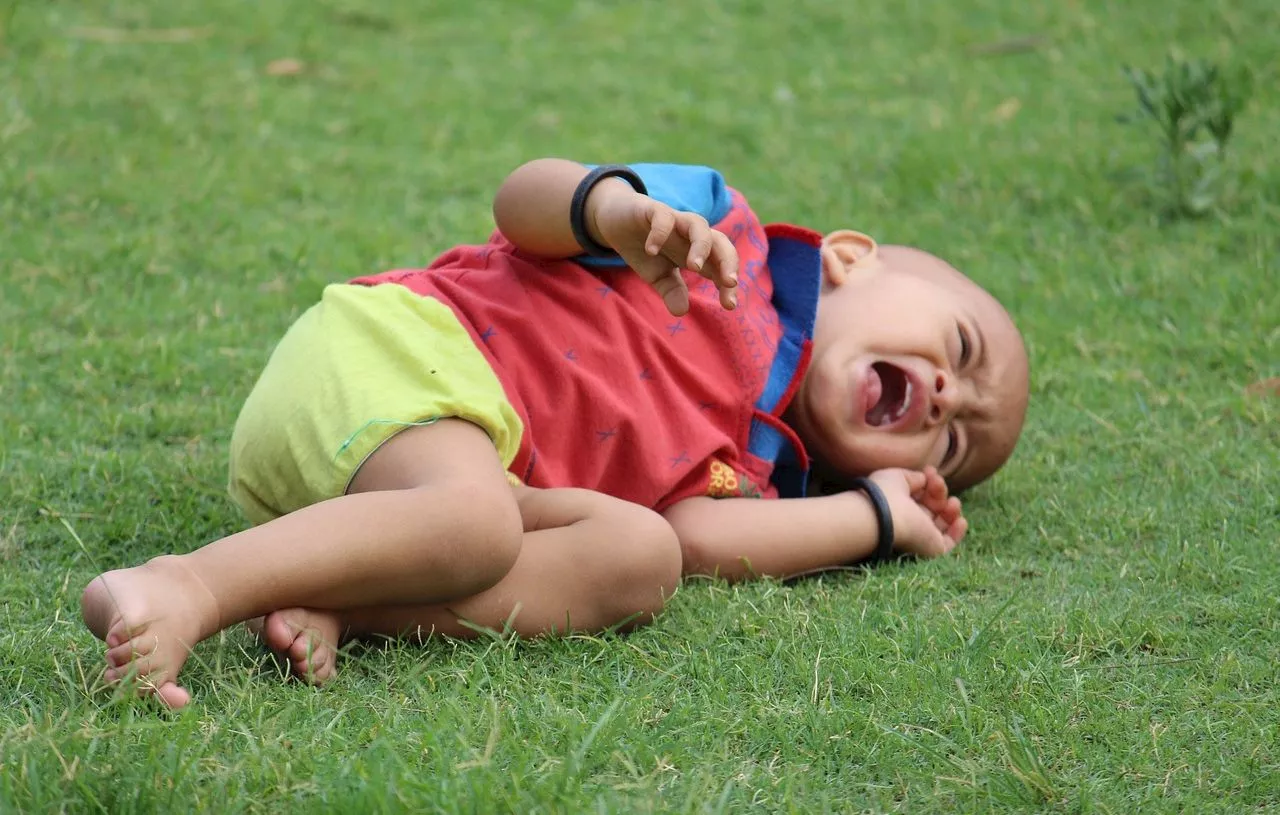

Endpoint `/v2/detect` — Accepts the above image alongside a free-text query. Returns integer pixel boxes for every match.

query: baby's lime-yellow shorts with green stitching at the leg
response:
[229,284,524,523]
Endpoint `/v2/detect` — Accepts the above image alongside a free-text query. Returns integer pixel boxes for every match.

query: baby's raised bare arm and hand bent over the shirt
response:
[493,159,737,315]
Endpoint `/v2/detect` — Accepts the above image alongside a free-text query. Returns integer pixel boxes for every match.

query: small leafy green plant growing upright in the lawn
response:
[1124,56,1252,218]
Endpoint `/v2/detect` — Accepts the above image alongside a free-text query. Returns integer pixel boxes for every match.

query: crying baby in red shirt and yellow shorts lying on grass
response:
[82,159,1028,708]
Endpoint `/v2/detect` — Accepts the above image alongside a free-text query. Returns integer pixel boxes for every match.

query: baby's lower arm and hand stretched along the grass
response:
[663,467,968,580]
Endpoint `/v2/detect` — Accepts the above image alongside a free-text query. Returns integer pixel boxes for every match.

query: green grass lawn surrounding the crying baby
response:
[0,0,1280,812]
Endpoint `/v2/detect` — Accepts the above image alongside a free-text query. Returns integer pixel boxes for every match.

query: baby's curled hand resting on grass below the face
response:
[870,467,969,558]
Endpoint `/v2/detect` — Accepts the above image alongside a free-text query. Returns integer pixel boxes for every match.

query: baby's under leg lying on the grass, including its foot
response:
[262,487,680,682]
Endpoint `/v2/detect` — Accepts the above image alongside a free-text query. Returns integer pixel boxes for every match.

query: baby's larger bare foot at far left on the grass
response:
[81,555,219,708]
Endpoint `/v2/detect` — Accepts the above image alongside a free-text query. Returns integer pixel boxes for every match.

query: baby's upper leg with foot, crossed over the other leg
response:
[81,420,521,708]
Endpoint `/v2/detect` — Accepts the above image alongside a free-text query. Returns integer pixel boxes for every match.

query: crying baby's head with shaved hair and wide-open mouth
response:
[787,230,1028,490]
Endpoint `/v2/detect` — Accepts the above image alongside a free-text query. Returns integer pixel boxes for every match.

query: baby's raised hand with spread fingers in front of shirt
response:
[586,179,737,317]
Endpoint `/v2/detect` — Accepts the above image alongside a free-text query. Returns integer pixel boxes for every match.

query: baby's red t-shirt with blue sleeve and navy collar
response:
[353,165,820,510]
